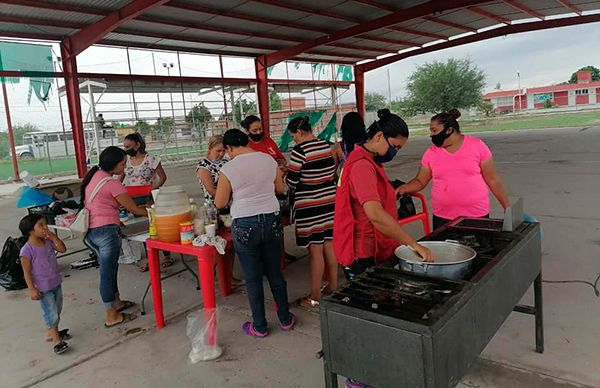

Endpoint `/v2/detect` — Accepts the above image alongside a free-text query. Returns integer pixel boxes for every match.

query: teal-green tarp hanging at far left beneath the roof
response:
[0,42,54,103]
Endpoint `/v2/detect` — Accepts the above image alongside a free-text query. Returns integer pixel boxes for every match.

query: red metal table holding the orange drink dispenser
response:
[146,231,234,338]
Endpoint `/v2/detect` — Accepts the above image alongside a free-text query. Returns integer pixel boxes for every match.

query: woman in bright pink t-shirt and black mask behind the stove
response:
[397,109,510,229]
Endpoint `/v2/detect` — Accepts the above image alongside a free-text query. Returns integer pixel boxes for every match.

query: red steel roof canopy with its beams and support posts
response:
[0,0,600,177]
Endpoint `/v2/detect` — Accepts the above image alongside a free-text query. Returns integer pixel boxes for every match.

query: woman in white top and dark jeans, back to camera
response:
[215,129,296,337]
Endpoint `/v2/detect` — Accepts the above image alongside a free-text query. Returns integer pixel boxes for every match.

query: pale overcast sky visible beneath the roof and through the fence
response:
[0,23,600,131]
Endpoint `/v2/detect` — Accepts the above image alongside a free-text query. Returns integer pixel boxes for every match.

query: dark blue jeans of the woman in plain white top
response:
[231,213,290,333]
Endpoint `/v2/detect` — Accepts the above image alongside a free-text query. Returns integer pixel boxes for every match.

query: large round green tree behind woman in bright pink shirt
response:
[407,58,485,112]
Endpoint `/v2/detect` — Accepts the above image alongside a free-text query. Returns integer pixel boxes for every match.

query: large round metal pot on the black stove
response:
[395,240,477,279]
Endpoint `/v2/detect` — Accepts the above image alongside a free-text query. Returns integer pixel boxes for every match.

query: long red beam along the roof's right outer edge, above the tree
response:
[354,14,600,72]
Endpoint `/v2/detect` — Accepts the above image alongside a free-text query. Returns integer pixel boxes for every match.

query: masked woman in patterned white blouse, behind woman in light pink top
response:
[120,132,174,272]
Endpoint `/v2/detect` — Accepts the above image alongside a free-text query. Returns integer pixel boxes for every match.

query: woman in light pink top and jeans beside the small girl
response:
[81,146,147,328]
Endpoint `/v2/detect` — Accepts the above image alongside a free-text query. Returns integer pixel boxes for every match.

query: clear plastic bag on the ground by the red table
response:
[186,308,223,364]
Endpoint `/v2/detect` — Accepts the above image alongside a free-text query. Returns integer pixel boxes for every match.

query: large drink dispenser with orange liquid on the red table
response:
[154,186,192,243]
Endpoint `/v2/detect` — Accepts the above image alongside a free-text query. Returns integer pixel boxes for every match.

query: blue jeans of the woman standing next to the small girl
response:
[85,225,121,310]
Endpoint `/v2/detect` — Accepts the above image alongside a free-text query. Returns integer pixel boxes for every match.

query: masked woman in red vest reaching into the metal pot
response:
[333,109,433,280]
